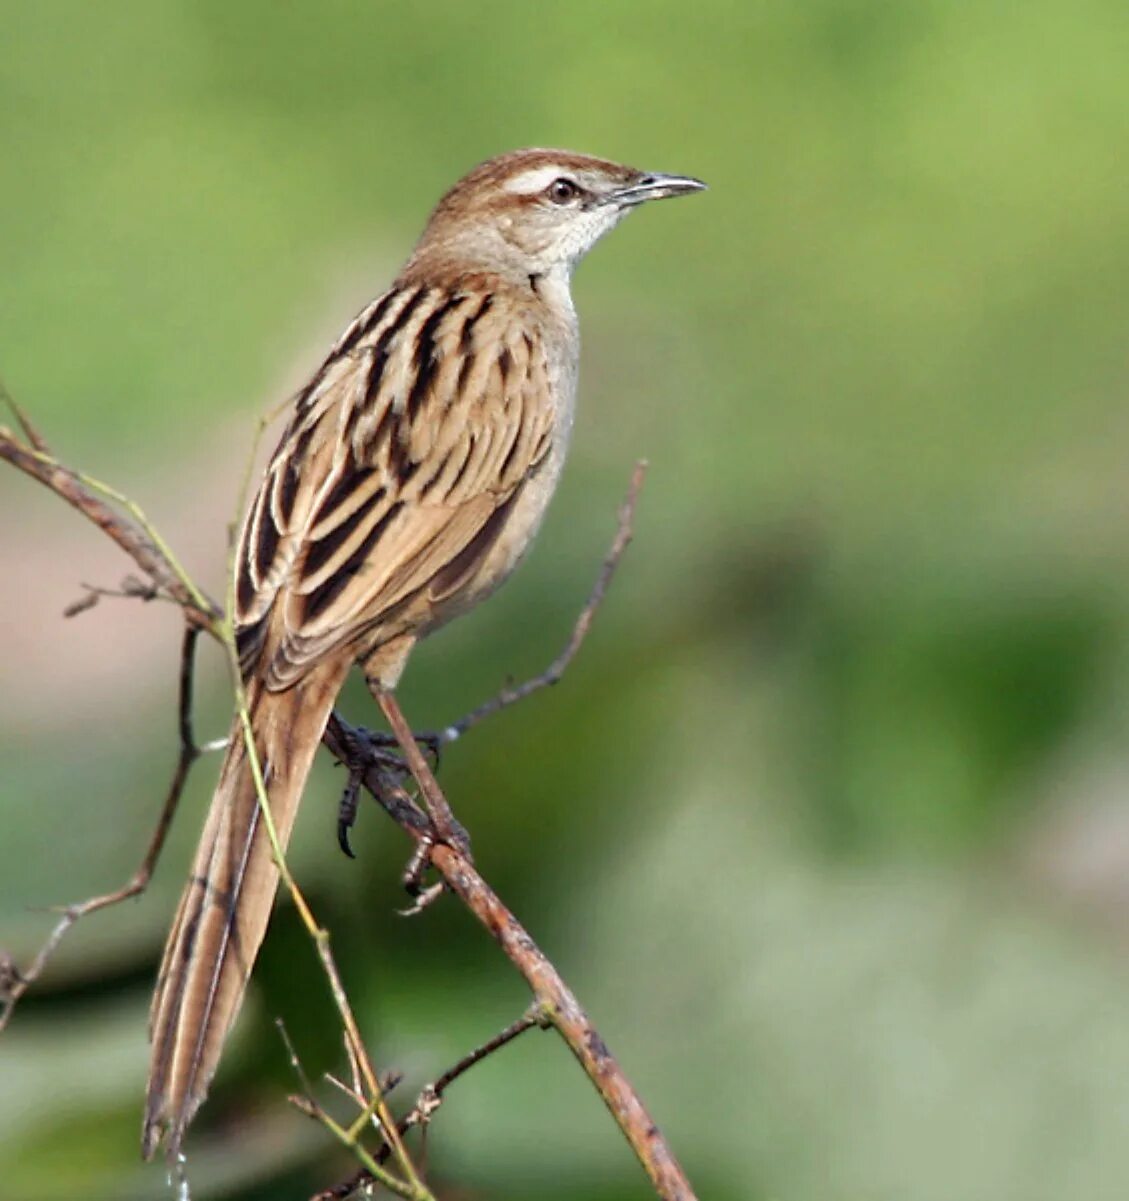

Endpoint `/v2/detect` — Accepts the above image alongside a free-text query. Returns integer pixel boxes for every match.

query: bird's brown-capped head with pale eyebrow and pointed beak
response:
[406,150,705,282]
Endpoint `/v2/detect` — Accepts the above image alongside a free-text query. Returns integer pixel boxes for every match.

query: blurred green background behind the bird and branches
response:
[0,0,1129,1201]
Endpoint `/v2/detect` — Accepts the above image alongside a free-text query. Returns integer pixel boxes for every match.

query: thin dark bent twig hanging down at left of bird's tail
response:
[0,626,201,1030]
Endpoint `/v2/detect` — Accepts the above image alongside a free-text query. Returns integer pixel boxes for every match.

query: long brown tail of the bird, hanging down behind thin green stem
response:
[142,662,348,1159]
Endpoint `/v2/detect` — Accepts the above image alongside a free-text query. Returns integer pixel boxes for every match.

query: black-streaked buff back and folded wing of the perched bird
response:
[235,287,554,688]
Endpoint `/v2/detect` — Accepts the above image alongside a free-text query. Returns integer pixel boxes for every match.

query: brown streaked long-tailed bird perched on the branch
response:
[142,148,705,1160]
